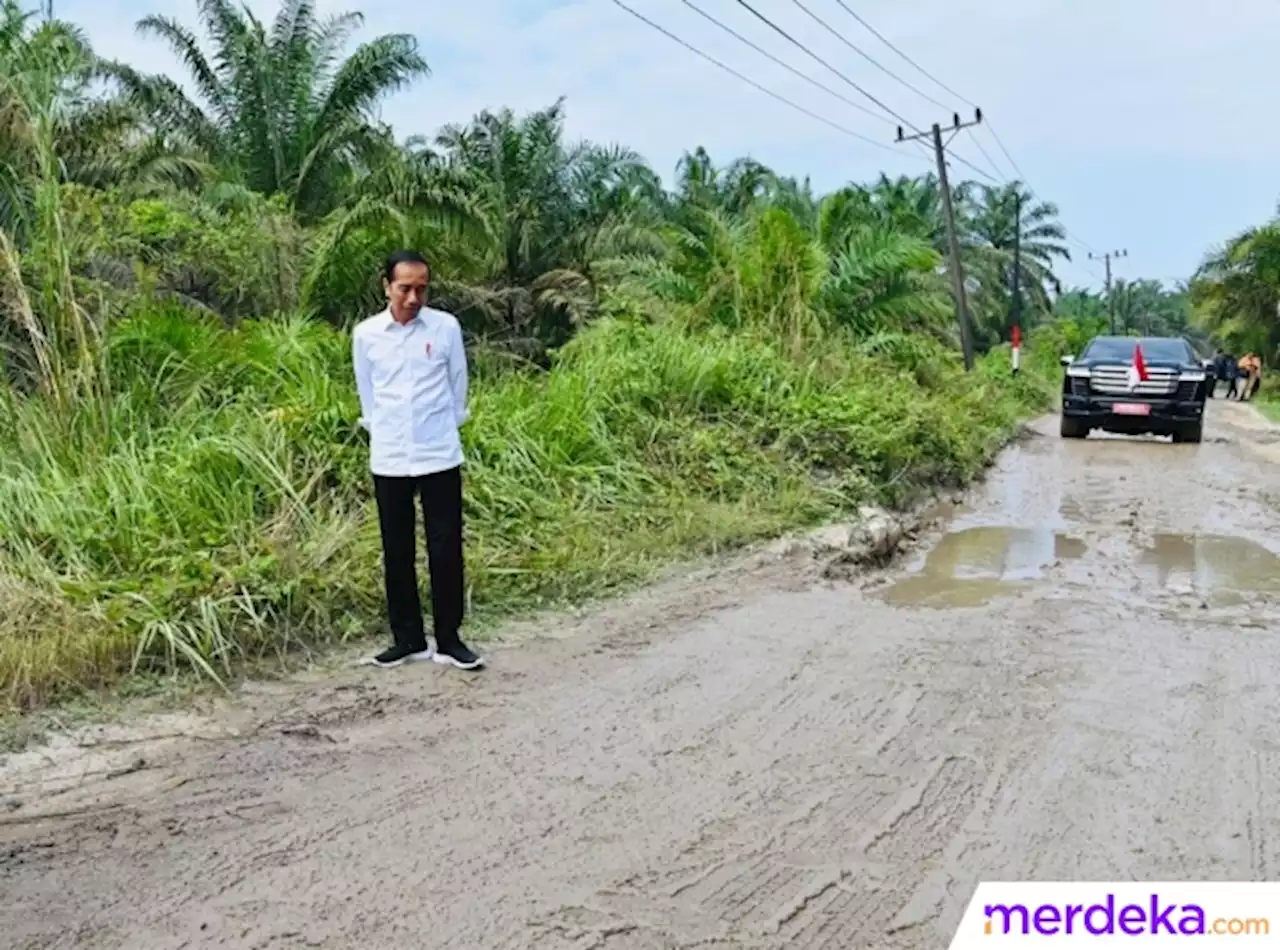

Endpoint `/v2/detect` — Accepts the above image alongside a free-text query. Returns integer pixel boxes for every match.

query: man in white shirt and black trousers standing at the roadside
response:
[352,251,484,670]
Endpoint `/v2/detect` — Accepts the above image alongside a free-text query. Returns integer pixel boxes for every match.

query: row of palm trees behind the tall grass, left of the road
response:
[0,0,1111,375]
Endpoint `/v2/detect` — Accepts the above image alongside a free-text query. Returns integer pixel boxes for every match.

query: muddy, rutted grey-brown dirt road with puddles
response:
[0,403,1280,950]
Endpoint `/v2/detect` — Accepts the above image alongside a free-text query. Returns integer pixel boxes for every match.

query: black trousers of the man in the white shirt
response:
[374,467,465,650]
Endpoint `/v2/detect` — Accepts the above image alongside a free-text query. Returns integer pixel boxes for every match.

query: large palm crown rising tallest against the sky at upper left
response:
[109,0,429,220]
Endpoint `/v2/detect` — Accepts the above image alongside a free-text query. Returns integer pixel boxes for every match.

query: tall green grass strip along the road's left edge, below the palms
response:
[0,309,1051,709]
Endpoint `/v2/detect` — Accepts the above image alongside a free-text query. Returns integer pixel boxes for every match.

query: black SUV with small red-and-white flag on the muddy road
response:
[1062,337,1213,442]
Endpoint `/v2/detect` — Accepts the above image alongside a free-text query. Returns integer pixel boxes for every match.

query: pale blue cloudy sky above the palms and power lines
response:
[54,0,1280,294]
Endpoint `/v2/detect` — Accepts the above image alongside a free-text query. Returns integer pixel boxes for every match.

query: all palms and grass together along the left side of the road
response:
[0,0,1074,711]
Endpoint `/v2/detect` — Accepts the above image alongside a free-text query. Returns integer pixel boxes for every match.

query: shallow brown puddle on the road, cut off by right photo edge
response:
[1139,534,1280,603]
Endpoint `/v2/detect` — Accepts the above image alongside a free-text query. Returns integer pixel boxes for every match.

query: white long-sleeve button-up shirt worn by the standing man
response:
[351,307,467,475]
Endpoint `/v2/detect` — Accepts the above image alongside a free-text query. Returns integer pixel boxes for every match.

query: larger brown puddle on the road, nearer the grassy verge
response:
[881,526,1085,607]
